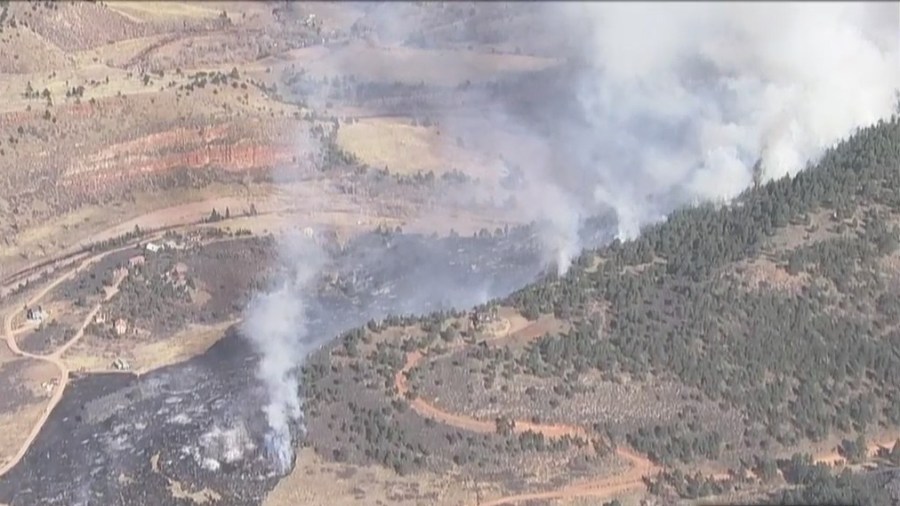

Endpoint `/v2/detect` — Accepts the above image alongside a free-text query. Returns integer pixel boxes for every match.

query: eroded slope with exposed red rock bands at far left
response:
[0,91,303,231]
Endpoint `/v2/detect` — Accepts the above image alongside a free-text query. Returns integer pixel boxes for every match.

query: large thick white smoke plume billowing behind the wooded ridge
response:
[555,2,900,244]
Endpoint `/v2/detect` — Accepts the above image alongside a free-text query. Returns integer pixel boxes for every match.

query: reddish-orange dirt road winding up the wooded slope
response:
[394,320,660,506]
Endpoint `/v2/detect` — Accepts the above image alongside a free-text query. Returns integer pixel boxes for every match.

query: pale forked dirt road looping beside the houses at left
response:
[0,251,133,476]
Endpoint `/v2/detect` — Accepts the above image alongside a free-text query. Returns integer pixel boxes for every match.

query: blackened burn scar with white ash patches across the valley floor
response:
[0,223,608,506]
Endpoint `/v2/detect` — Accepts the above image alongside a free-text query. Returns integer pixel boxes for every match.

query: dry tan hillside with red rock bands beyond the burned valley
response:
[0,1,556,279]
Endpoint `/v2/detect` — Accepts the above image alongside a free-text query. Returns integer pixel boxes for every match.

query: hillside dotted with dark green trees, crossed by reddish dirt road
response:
[307,117,900,504]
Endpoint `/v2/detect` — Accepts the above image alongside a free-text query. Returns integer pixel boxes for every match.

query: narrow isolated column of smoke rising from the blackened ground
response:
[242,229,327,474]
